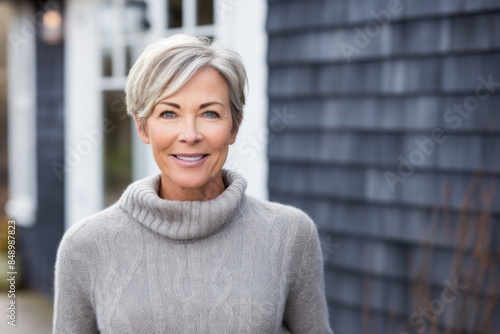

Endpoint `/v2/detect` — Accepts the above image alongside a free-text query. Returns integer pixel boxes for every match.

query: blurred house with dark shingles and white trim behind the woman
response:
[0,0,500,334]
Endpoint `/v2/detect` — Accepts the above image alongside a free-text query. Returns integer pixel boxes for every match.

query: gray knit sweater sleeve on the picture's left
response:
[53,224,98,334]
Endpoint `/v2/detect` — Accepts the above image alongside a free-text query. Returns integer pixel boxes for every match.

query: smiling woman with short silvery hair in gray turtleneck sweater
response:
[54,35,331,334]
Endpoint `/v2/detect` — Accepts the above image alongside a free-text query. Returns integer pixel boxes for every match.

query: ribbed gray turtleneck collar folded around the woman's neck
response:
[119,170,247,241]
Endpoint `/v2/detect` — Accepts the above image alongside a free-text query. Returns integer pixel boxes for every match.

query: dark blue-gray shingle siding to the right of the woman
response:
[267,0,500,334]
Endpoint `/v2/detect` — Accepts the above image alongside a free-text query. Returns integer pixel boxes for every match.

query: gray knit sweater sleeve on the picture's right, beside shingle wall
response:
[284,217,333,334]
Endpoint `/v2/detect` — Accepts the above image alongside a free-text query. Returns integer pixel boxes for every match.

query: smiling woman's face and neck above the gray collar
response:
[137,69,237,200]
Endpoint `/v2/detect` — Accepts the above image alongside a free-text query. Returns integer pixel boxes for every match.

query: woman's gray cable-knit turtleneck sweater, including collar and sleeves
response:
[54,171,332,334]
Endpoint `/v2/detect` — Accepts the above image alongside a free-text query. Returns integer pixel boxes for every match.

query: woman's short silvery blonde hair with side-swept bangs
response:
[125,34,247,130]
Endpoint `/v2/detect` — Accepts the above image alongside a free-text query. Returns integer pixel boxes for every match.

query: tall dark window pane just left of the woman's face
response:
[103,91,132,206]
